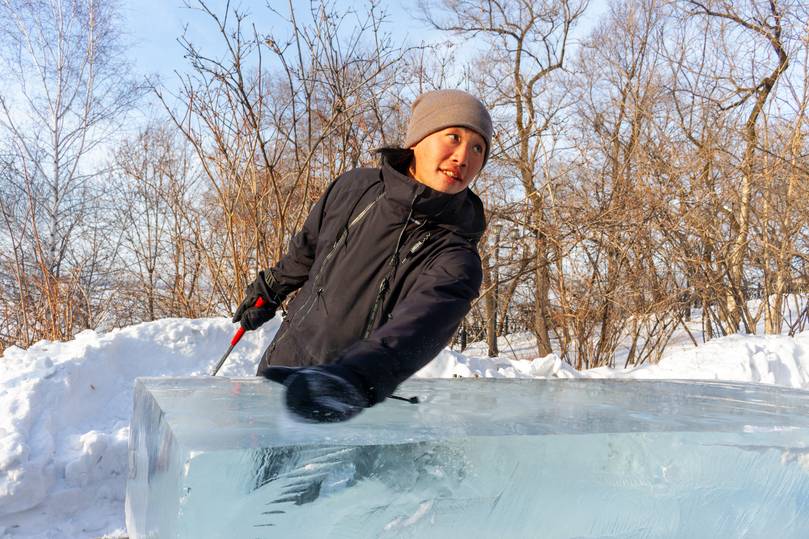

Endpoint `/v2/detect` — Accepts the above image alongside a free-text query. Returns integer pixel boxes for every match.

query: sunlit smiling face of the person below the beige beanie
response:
[409,127,486,195]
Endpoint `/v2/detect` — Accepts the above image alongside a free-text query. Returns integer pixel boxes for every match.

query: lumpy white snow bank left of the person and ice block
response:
[0,318,277,538]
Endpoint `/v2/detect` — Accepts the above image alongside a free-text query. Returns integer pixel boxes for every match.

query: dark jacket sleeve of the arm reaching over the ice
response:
[336,251,482,404]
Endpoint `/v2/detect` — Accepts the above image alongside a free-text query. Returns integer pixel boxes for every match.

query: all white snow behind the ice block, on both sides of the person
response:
[0,318,809,539]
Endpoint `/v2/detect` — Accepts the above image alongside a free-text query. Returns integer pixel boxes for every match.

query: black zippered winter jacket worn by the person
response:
[258,162,485,404]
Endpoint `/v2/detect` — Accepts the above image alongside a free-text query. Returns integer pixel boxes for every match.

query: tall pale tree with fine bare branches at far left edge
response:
[0,0,139,350]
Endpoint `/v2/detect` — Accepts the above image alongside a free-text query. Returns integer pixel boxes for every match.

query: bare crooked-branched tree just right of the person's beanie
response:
[421,0,587,356]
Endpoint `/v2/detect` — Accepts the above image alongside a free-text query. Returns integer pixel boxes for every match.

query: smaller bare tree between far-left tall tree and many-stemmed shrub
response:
[113,124,208,322]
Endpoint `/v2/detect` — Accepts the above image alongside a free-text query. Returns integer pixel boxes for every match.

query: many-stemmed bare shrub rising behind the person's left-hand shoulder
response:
[156,1,416,314]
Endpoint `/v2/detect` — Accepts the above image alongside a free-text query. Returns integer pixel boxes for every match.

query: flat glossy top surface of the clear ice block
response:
[135,377,809,451]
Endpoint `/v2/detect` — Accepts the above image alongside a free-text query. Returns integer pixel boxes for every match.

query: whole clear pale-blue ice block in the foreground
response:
[126,378,809,539]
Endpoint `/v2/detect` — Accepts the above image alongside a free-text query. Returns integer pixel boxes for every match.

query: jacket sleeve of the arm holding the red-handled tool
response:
[267,178,340,298]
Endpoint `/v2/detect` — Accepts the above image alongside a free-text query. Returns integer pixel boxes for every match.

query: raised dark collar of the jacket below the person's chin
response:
[382,160,486,243]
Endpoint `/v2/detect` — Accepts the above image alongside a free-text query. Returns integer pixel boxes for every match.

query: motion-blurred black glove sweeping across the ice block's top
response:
[261,364,371,423]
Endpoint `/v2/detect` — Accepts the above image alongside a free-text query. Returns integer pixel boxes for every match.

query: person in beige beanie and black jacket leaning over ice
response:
[233,90,492,421]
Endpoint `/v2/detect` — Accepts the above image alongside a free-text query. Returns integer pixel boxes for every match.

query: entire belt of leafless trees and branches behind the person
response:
[0,0,809,368]
